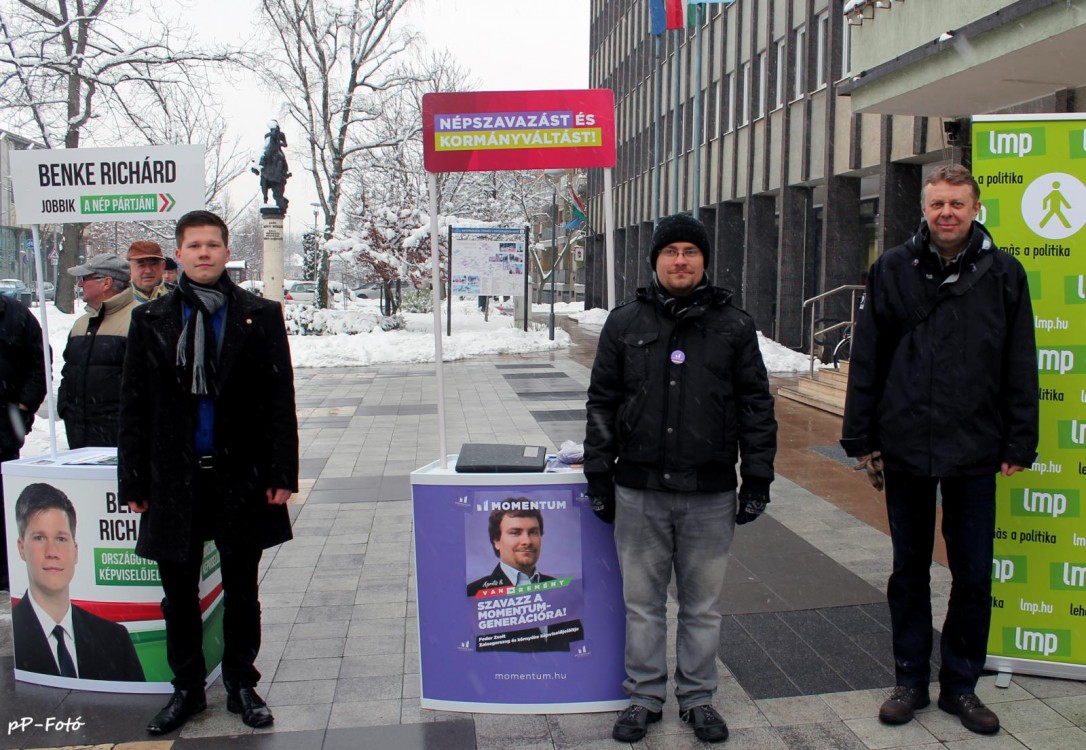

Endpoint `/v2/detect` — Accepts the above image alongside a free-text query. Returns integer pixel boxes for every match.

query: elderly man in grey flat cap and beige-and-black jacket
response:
[56,254,137,448]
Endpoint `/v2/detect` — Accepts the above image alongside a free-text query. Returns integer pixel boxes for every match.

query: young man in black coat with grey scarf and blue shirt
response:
[117,211,298,735]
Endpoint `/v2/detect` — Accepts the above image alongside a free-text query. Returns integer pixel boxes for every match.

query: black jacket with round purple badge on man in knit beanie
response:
[584,288,776,496]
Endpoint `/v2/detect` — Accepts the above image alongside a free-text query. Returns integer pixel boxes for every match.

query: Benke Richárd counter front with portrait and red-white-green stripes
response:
[3,448,223,692]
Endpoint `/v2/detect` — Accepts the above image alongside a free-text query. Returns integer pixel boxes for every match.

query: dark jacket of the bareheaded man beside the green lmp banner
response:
[841,223,1037,478]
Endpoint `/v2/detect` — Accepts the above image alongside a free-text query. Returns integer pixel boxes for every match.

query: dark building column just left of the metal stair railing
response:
[776,188,812,346]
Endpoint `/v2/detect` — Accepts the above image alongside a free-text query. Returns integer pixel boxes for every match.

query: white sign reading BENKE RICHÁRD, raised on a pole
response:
[11,145,204,224]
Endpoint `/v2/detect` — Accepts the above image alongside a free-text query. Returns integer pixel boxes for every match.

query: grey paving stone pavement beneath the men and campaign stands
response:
[0,322,1086,750]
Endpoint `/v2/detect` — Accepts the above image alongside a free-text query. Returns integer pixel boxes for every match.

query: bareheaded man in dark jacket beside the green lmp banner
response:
[841,165,1037,734]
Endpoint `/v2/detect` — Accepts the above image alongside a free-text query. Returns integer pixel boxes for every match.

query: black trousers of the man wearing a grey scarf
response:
[159,471,263,690]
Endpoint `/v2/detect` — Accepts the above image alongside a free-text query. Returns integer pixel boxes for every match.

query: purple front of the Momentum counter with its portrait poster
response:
[413,473,627,713]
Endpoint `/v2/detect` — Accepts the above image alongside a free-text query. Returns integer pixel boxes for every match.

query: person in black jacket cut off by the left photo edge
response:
[0,294,46,590]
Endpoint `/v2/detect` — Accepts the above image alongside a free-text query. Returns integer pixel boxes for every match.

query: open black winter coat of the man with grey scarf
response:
[117,284,298,561]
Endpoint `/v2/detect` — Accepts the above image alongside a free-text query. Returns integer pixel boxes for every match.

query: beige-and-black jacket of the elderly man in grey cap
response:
[56,287,136,448]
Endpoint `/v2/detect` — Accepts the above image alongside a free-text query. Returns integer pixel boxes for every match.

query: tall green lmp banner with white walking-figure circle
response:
[973,114,1086,678]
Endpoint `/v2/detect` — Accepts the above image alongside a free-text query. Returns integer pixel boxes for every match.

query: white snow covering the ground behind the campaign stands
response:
[23,297,808,456]
